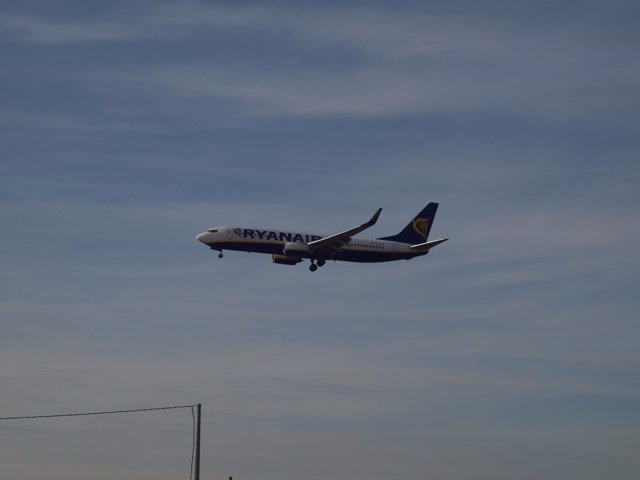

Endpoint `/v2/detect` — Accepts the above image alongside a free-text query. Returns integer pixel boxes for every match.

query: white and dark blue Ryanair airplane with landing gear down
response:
[196,203,448,272]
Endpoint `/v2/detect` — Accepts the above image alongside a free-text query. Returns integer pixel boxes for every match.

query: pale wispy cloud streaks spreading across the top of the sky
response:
[4,3,640,123]
